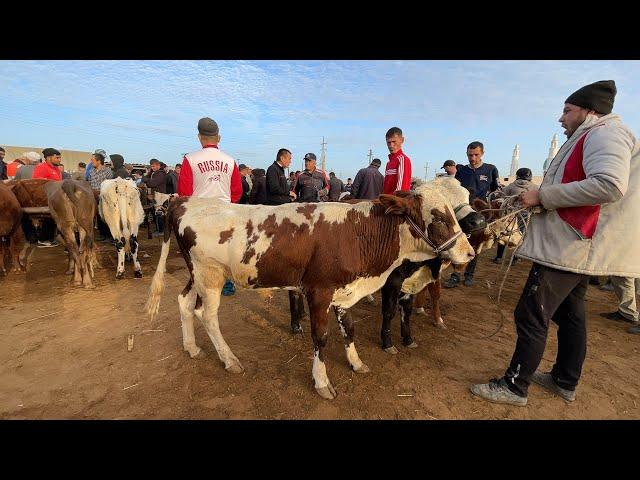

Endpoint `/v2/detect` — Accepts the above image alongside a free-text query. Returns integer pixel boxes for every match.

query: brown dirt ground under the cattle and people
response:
[0,236,640,420]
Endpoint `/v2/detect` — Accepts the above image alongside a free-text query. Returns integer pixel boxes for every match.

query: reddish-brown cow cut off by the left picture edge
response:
[0,183,24,274]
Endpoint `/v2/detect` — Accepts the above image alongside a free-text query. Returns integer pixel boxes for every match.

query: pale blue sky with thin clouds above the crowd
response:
[0,60,640,180]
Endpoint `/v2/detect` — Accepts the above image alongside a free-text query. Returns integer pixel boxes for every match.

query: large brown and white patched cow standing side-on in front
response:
[147,192,474,399]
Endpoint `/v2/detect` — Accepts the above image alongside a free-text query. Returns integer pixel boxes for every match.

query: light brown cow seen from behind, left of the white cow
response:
[44,180,96,288]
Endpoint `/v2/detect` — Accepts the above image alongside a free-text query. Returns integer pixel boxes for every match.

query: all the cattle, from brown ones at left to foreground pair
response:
[0,174,520,399]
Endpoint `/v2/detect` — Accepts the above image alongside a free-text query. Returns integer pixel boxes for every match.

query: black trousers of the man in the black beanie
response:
[504,263,589,397]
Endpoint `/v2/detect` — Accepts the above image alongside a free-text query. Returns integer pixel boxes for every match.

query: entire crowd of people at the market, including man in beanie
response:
[0,80,640,405]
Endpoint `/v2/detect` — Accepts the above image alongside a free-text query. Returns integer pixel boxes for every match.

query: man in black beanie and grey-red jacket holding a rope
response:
[471,80,640,406]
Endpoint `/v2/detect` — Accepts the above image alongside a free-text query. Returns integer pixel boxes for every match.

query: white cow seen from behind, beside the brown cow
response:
[99,178,144,280]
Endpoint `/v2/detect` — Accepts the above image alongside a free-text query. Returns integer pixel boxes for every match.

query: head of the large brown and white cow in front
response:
[378,190,474,264]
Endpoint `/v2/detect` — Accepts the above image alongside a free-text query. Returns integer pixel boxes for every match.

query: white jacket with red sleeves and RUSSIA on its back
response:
[178,145,242,203]
